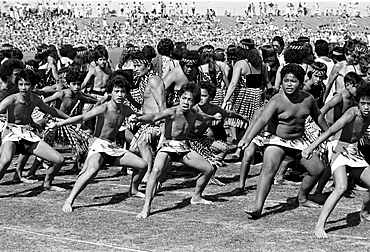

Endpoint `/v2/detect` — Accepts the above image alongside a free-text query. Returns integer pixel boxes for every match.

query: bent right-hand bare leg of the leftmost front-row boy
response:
[29,141,65,192]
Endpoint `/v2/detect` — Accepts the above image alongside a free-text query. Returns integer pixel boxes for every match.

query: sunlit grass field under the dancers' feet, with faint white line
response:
[0,148,370,252]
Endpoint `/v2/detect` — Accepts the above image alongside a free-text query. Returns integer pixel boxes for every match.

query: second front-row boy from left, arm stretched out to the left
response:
[53,75,147,212]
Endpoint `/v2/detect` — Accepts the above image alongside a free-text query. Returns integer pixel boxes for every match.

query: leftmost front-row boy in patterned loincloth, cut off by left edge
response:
[0,69,68,191]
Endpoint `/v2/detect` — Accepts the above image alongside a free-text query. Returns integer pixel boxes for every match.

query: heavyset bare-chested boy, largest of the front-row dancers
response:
[242,64,328,219]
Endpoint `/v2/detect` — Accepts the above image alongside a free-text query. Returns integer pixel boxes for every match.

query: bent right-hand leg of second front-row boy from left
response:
[115,151,148,198]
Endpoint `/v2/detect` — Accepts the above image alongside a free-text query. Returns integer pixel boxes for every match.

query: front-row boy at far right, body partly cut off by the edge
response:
[302,83,370,238]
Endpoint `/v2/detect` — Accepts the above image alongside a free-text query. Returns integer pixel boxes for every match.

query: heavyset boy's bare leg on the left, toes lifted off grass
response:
[247,145,285,219]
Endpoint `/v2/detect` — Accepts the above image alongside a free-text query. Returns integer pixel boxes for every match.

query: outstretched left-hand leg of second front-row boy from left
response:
[62,153,103,213]
